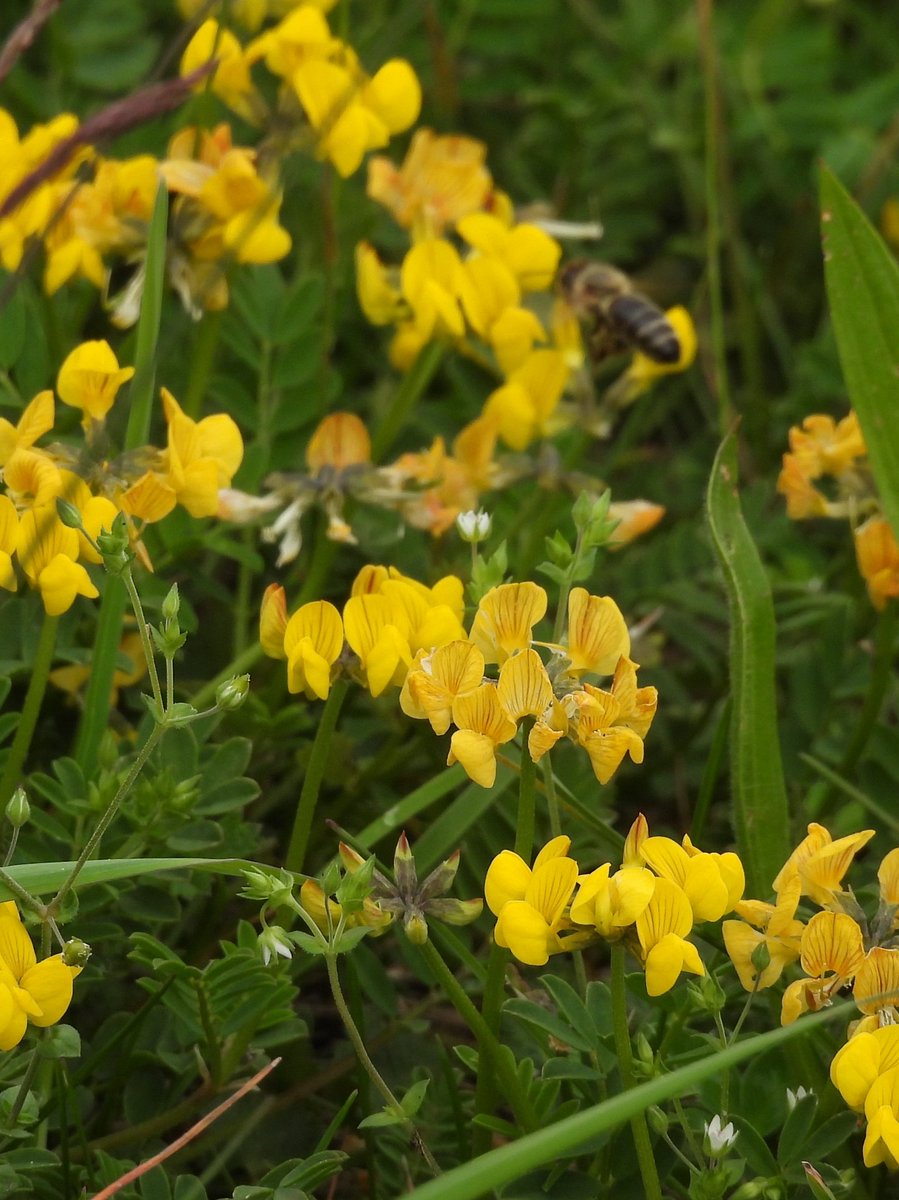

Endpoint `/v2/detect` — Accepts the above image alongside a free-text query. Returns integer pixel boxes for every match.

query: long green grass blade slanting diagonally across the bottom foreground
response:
[406,1003,855,1200]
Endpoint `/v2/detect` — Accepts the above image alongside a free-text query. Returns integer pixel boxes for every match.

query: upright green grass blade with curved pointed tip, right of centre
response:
[707,433,790,896]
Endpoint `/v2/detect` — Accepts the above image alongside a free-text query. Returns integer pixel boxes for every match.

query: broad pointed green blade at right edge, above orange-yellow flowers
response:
[821,167,899,535]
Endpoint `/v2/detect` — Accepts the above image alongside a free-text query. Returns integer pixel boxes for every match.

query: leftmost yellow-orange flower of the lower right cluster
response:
[721,875,804,991]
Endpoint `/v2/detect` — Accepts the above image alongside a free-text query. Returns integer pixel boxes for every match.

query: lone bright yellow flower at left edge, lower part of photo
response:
[0,901,79,1050]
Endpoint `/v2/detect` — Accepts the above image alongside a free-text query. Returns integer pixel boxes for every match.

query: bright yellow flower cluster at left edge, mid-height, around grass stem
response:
[0,342,244,616]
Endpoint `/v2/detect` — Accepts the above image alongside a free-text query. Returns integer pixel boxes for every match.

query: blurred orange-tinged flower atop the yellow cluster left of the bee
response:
[367,130,492,238]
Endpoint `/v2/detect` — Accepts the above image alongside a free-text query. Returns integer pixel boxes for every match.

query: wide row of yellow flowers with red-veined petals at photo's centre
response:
[260,576,658,787]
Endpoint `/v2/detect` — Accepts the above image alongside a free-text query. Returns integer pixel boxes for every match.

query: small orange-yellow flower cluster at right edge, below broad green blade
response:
[778,413,899,608]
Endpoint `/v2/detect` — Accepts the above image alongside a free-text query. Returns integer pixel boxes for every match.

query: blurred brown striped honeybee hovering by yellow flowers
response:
[559,259,681,365]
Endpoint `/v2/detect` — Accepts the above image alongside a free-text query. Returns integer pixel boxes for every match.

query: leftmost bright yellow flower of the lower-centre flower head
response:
[484,836,577,966]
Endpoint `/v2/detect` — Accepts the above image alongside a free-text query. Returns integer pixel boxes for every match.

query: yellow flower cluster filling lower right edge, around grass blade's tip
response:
[723,823,899,1169]
